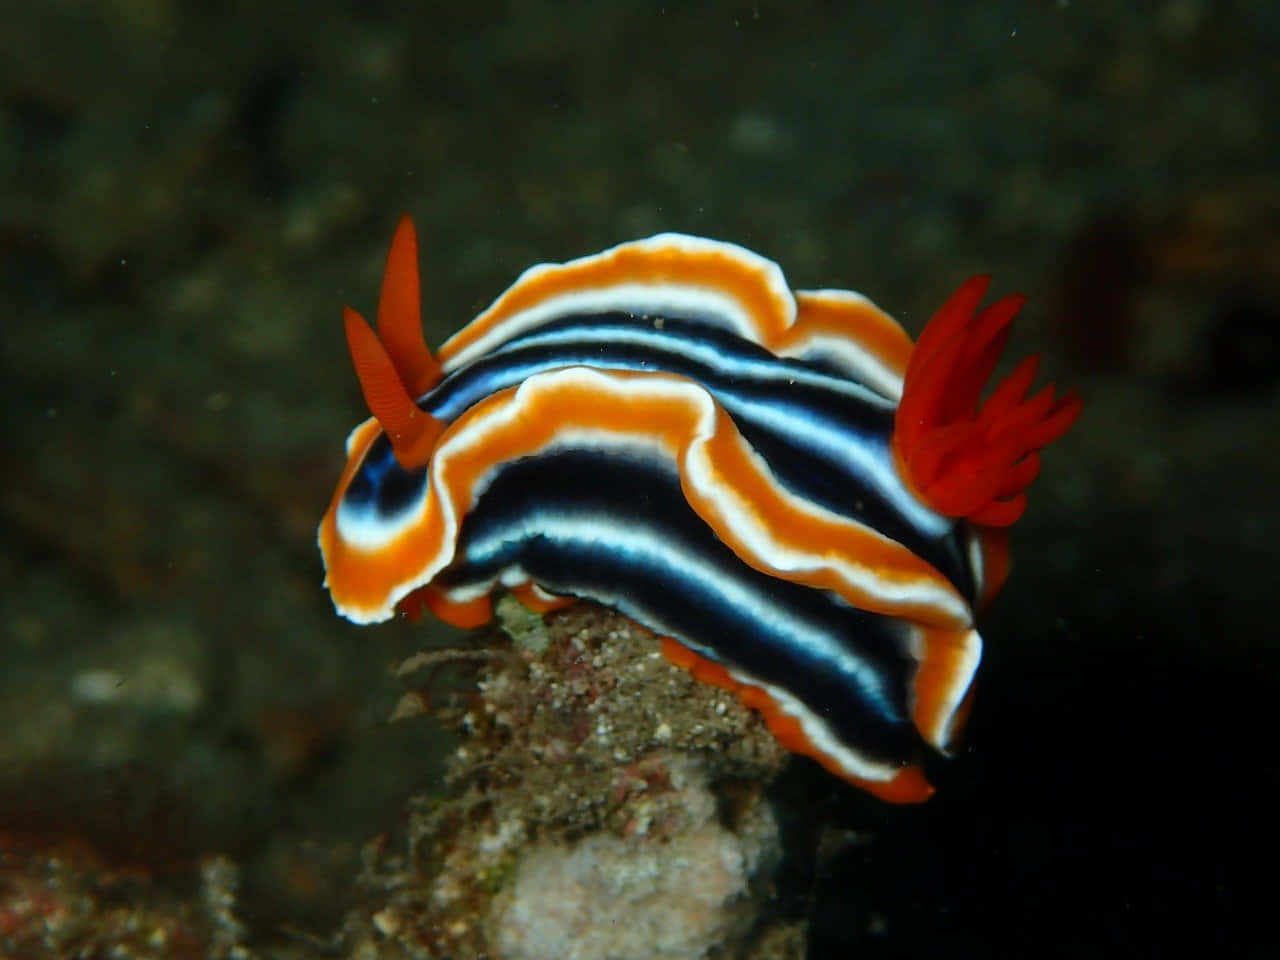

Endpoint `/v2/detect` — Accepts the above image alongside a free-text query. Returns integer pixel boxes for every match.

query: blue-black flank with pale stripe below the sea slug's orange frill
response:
[435,448,931,763]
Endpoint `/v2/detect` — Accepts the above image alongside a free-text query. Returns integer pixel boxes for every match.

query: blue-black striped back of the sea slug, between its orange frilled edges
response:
[346,314,978,603]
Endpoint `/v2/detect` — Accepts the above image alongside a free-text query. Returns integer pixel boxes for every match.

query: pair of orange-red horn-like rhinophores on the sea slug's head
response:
[342,216,444,470]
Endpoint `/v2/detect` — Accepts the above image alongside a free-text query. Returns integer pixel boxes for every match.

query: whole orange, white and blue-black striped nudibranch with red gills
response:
[319,218,1080,801]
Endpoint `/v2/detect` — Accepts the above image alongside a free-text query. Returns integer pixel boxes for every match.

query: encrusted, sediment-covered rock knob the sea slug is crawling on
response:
[348,602,803,960]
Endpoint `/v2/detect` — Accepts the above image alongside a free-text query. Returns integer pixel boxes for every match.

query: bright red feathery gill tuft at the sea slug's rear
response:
[893,275,1082,526]
